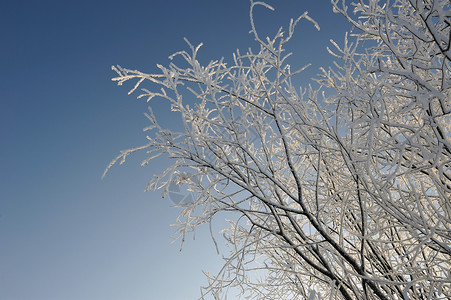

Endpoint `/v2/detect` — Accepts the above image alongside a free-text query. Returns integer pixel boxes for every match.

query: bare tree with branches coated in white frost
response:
[104,0,451,299]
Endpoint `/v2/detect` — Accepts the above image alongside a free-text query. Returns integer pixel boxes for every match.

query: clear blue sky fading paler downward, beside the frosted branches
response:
[0,0,349,300]
